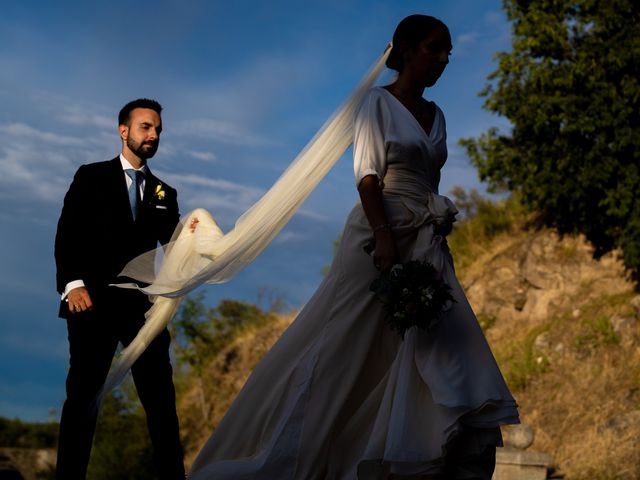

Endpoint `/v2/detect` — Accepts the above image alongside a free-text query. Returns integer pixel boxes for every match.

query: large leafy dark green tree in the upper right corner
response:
[461,0,640,278]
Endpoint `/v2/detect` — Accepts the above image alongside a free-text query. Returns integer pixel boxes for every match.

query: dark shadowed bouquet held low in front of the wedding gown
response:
[369,260,455,339]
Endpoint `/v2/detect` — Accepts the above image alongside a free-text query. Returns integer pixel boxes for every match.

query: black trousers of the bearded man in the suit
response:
[56,287,185,480]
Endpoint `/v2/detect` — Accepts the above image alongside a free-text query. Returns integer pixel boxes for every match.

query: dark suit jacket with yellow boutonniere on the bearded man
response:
[55,157,180,318]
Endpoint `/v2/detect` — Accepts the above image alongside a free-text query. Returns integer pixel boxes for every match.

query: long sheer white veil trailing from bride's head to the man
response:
[102,45,391,395]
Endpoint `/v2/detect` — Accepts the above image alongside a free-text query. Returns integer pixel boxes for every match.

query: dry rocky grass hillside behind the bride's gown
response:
[180,226,640,480]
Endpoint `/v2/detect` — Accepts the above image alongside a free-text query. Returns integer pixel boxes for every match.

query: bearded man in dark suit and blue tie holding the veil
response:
[55,99,184,480]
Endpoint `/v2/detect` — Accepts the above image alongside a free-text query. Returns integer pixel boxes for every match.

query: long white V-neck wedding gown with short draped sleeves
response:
[188,87,518,480]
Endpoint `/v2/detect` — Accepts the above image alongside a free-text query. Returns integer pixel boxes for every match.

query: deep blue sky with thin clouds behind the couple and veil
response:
[0,0,510,420]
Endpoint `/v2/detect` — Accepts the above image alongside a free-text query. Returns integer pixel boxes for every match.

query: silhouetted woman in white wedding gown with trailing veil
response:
[110,15,518,480]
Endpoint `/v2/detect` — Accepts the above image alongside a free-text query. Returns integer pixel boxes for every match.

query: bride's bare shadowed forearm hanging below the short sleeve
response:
[358,175,396,271]
